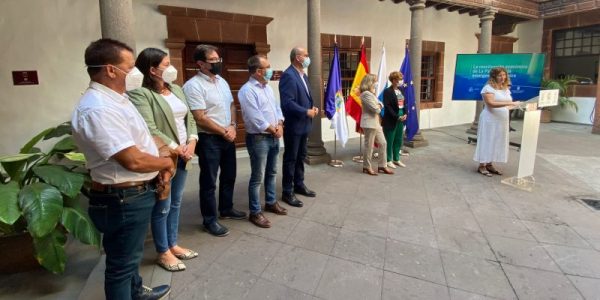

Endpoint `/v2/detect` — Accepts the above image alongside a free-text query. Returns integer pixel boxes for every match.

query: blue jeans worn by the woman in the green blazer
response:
[150,159,187,253]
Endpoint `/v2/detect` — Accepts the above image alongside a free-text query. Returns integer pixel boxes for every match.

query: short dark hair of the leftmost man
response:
[85,39,133,77]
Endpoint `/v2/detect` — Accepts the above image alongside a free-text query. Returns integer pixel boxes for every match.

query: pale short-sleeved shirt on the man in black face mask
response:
[183,72,233,132]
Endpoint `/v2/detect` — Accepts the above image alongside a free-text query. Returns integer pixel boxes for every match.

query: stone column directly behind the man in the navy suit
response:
[306,0,331,165]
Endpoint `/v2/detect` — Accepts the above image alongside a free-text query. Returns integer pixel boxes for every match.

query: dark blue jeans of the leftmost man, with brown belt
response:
[88,184,156,300]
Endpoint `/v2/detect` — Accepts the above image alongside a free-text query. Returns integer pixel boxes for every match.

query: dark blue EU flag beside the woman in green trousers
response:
[400,47,419,141]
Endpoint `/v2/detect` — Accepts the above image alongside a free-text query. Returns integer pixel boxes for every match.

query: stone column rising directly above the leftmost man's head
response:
[99,0,135,54]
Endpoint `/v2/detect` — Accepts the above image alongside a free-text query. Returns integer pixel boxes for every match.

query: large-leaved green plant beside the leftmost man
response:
[0,122,100,273]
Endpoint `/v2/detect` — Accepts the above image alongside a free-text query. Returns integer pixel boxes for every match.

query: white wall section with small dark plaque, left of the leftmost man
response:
[0,0,100,155]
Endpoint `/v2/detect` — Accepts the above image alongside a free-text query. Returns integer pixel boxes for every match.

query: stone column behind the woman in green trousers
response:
[405,0,429,148]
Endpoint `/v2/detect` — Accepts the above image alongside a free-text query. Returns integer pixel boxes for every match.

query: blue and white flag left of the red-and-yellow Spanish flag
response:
[325,45,348,147]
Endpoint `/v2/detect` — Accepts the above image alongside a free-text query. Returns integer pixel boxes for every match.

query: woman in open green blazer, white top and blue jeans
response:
[128,48,198,271]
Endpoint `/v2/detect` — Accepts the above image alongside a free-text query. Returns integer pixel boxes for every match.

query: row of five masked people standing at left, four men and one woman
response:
[72,39,319,299]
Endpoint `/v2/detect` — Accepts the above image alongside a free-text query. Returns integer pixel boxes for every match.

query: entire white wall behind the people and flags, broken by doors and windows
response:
[0,0,479,155]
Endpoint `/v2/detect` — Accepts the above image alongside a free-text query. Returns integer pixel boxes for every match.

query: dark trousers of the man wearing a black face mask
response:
[196,133,237,225]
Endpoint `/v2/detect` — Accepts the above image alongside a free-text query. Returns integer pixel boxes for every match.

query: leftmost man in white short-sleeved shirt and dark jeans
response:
[71,39,175,299]
